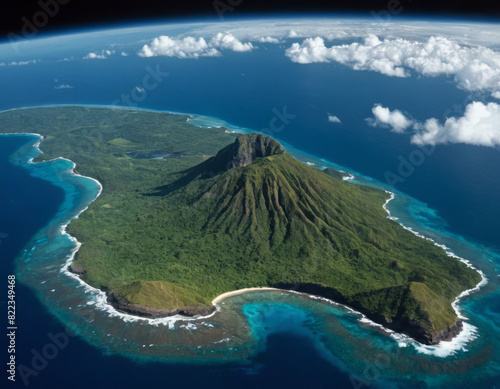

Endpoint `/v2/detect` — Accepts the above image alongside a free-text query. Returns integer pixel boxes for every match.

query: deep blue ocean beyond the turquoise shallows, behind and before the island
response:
[0,22,500,388]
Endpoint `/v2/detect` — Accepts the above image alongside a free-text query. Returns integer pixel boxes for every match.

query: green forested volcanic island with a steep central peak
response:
[2,107,481,344]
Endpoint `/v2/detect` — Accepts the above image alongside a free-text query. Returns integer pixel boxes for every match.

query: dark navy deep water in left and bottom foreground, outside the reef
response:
[0,136,370,389]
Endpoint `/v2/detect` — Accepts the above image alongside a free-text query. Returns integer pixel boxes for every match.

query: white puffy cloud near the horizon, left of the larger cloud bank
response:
[138,32,254,58]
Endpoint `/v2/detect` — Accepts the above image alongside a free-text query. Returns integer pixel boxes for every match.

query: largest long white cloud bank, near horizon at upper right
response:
[286,34,500,93]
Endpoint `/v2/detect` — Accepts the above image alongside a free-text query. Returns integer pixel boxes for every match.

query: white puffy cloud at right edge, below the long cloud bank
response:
[411,101,500,147]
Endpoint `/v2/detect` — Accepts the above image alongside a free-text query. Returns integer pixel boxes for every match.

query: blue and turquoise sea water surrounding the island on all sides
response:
[0,19,500,389]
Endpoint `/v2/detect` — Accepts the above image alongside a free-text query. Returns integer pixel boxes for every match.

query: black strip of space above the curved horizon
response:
[0,0,500,37]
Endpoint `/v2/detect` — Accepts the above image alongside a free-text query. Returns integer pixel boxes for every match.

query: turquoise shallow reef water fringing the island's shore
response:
[0,107,500,387]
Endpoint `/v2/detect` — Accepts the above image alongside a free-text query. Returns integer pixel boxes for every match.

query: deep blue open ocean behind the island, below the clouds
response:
[0,34,500,248]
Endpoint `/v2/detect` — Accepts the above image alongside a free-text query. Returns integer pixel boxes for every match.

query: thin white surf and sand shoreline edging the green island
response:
[2,105,487,354]
